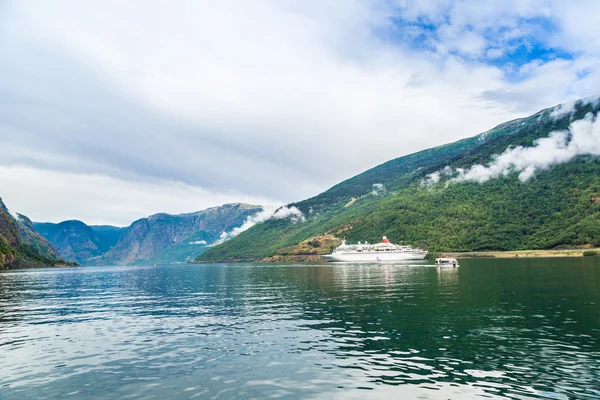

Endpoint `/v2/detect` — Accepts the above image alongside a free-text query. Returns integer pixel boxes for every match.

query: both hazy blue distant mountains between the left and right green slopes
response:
[34,203,262,265]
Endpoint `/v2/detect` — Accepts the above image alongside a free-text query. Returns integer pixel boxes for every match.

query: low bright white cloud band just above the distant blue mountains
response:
[0,166,275,226]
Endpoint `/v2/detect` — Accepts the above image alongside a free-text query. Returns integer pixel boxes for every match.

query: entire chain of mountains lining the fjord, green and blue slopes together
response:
[8,98,600,268]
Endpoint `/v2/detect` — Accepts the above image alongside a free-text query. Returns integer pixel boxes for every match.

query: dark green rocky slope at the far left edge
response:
[0,199,63,270]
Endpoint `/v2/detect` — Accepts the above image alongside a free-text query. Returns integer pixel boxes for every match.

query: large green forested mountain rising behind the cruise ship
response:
[197,95,600,262]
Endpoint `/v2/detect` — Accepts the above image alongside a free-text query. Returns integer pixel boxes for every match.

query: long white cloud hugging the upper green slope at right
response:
[451,114,600,183]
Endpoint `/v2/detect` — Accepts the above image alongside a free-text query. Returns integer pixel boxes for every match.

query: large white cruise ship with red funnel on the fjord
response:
[323,236,427,262]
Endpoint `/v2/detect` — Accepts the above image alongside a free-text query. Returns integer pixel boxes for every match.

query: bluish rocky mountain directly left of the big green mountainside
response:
[99,203,262,265]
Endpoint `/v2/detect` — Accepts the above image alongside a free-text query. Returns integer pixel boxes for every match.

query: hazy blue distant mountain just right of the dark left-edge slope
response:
[33,220,125,264]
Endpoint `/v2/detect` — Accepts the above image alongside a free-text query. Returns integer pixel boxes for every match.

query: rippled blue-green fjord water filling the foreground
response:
[0,258,600,399]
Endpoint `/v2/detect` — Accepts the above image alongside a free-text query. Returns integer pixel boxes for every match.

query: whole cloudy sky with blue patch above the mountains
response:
[0,0,600,225]
